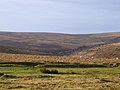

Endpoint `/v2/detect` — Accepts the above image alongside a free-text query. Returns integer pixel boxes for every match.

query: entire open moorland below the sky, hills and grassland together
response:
[0,32,120,90]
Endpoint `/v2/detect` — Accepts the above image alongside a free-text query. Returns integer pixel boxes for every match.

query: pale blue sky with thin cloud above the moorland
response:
[0,0,120,34]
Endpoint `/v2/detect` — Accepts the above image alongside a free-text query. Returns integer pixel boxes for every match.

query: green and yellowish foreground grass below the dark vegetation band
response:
[0,62,120,90]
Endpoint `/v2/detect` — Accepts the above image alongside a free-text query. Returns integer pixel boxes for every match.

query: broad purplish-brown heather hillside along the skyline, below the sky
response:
[0,32,120,55]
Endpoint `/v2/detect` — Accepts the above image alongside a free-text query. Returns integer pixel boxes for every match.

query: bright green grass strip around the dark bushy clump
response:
[0,66,120,75]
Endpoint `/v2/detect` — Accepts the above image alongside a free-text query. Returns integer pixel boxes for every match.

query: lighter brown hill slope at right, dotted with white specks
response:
[78,43,120,59]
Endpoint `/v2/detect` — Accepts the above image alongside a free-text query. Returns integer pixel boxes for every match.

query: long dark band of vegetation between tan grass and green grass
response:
[0,62,120,70]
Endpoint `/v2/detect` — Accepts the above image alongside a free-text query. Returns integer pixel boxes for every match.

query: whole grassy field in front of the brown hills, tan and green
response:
[0,54,120,90]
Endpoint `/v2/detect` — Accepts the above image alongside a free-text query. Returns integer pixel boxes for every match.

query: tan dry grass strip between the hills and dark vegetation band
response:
[0,53,120,65]
